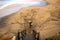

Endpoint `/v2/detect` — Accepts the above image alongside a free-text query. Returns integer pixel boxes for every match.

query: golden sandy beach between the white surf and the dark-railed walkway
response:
[0,0,60,40]
